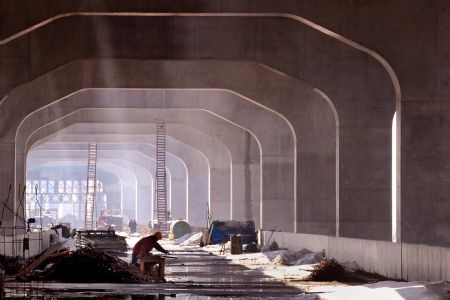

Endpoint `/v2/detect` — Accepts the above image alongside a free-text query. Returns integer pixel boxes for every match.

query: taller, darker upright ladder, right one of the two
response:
[156,120,169,232]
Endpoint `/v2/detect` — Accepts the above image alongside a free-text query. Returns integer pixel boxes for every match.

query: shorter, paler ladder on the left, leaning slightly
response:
[84,143,97,230]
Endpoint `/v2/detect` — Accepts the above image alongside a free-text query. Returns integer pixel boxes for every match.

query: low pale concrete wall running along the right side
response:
[262,231,450,281]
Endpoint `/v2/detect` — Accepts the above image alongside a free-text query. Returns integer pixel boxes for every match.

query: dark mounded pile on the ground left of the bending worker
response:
[39,247,146,283]
